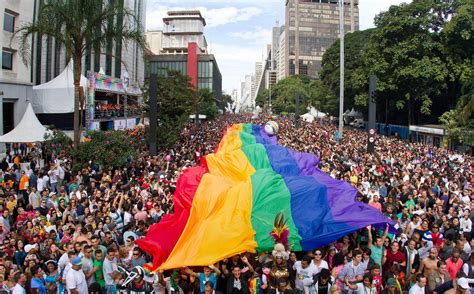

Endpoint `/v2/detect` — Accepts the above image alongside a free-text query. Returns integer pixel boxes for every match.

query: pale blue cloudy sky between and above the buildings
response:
[146,0,410,94]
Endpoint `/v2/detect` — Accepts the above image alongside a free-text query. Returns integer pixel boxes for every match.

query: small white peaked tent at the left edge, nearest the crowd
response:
[0,103,51,143]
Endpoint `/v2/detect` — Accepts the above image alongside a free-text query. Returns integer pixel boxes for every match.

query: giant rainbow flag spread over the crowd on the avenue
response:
[136,124,394,269]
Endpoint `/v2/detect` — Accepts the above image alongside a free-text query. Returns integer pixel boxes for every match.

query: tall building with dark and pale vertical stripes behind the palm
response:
[33,0,146,85]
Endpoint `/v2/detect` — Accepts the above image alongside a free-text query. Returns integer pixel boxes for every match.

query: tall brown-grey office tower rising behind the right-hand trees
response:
[280,0,359,79]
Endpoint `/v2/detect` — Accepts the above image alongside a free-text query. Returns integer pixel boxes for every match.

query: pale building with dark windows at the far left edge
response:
[0,1,34,134]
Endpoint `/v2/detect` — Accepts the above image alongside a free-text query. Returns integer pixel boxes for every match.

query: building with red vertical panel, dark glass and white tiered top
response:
[146,10,225,108]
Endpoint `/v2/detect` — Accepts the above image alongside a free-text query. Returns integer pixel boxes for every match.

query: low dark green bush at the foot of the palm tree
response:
[71,131,145,170]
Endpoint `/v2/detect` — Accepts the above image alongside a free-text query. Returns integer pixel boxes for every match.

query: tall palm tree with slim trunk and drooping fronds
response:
[14,0,145,148]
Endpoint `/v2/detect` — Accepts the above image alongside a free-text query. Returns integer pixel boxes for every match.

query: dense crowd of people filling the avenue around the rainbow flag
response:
[0,114,474,294]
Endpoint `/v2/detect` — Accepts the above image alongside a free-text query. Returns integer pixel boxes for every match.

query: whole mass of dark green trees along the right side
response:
[321,0,474,124]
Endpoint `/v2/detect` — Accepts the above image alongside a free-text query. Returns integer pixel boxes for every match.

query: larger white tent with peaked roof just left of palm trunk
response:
[32,62,88,113]
